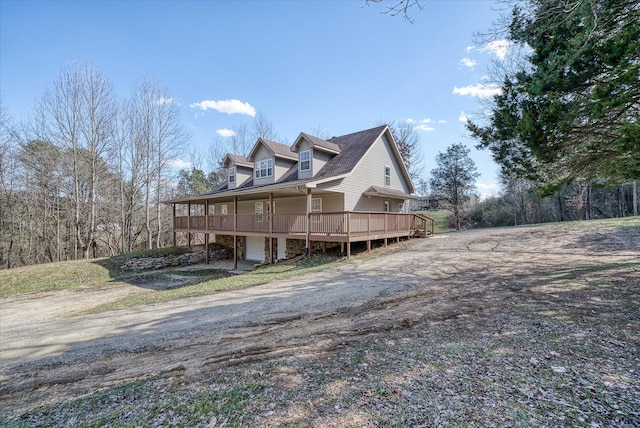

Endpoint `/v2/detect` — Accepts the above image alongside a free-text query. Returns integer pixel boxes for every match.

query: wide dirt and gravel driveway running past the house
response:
[0,224,640,422]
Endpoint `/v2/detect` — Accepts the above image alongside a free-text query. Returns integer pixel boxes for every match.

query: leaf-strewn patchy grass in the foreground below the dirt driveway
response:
[0,219,640,427]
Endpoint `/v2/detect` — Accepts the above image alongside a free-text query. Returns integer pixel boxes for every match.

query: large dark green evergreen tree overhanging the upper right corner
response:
[469,0,640,193]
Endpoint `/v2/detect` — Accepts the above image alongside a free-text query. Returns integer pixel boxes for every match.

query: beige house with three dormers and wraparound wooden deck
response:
[165,125,434,262]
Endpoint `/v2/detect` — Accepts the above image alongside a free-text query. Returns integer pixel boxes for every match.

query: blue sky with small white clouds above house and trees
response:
[0,0,507,194]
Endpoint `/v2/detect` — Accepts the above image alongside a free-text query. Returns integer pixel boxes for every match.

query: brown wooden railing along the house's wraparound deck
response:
[173,211,435,239]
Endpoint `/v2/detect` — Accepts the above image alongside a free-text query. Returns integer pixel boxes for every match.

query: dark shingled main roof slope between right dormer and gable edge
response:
[314,125,386,179]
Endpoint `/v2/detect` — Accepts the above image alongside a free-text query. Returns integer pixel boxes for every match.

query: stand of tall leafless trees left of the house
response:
[0,63,188,268]
